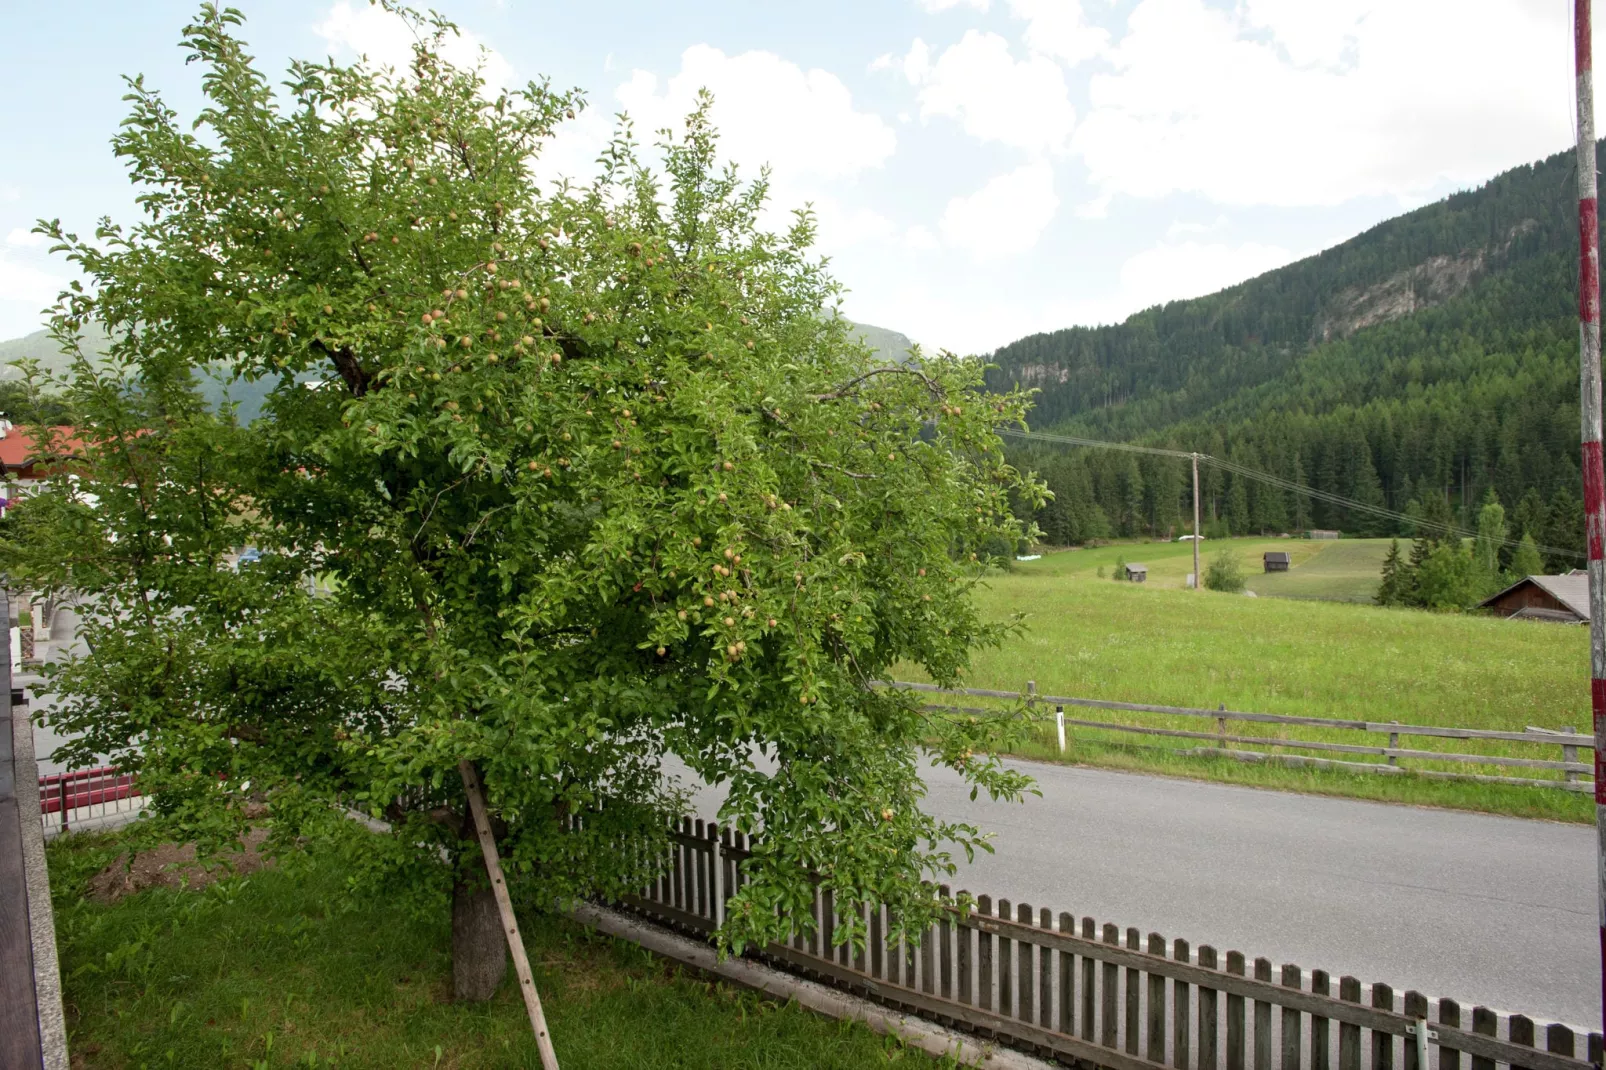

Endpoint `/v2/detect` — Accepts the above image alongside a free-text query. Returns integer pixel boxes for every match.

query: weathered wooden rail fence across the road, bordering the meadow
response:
[888,681,1595,792]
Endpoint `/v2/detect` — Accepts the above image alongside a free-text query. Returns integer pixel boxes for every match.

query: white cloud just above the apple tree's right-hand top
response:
[615,45,898,185]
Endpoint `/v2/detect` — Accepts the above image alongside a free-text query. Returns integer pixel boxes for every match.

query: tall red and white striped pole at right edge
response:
[1572,0,1606,1023]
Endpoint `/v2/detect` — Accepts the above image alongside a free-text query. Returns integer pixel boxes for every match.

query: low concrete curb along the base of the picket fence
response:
[569,903,1063,1070]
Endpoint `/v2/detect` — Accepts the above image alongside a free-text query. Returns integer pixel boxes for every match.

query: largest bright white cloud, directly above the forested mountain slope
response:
[1071,0,1571,206]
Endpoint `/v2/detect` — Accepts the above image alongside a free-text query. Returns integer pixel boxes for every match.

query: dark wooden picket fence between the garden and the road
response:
[622,818,1603,1070]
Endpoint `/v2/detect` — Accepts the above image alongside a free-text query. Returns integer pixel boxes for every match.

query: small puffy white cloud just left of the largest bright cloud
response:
[903,31,1076,153]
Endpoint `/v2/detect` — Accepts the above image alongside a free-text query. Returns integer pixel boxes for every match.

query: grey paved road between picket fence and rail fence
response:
[671,763,1601,1030]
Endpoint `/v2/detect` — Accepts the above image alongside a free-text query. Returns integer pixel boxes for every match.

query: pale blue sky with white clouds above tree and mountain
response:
[0,0,1593,353]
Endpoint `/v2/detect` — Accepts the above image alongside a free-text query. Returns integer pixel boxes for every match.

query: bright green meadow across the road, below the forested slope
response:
[911,540,1593,821]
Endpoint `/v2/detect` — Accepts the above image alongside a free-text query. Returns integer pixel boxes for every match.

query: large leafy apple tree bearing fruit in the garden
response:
[0,5,1040,998]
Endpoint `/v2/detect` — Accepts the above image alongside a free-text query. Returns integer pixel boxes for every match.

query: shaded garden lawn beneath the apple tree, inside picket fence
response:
[50,834,936,1070]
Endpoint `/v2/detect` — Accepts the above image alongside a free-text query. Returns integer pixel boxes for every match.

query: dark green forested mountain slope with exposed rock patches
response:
[988,141,1582,564]
